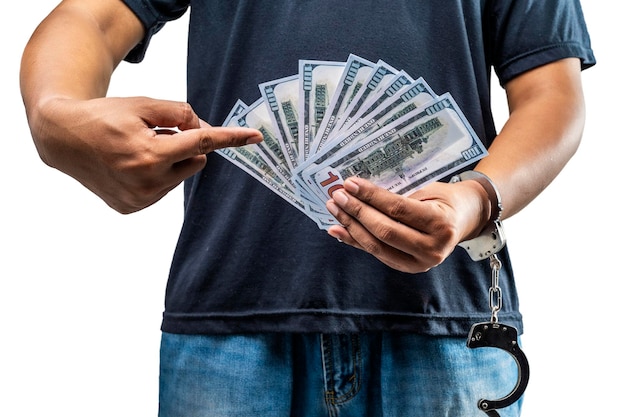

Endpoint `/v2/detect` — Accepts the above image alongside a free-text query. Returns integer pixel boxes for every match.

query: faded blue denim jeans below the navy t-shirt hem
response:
[159,333,521,417]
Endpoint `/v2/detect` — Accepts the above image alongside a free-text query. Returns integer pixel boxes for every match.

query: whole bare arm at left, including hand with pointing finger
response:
[20,0,261,213]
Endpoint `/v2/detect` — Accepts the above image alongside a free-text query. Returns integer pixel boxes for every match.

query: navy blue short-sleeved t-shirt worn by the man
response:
[119,0,595,336]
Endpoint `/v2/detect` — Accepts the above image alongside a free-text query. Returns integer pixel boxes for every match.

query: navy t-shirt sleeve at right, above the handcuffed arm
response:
[489,0,596,85]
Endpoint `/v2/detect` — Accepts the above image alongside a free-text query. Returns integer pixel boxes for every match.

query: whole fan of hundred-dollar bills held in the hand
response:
[217,54,487,229]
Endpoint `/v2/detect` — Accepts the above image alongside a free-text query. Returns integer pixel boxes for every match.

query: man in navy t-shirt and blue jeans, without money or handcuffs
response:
[21,0,595,416]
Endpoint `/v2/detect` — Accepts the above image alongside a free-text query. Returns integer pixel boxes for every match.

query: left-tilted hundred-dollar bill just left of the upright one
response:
[259,74,300,169]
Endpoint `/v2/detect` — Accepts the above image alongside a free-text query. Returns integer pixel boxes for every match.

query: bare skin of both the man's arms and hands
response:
[20,0,585,272]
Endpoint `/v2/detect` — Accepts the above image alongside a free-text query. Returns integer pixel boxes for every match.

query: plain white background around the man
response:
[0,0,626,417]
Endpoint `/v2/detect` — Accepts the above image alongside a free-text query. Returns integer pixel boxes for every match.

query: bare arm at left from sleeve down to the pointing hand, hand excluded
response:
[21,0,144,105]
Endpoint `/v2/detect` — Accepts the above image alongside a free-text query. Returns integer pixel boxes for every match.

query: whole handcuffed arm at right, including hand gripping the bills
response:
[327,58,585,272]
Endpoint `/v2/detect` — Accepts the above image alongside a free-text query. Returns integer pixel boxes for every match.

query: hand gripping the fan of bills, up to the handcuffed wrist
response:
[326,177,489,273]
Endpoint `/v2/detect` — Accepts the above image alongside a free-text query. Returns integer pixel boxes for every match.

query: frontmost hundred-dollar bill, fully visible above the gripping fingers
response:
[306,93,487,198]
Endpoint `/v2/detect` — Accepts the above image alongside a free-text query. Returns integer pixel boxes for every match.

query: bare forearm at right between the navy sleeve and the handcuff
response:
[476,59,585,218]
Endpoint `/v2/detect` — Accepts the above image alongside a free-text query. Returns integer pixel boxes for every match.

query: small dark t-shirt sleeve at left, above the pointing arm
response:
[123,0,189,62]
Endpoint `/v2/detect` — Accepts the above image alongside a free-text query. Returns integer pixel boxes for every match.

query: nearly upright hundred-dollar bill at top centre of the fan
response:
[298,60,346,162]
